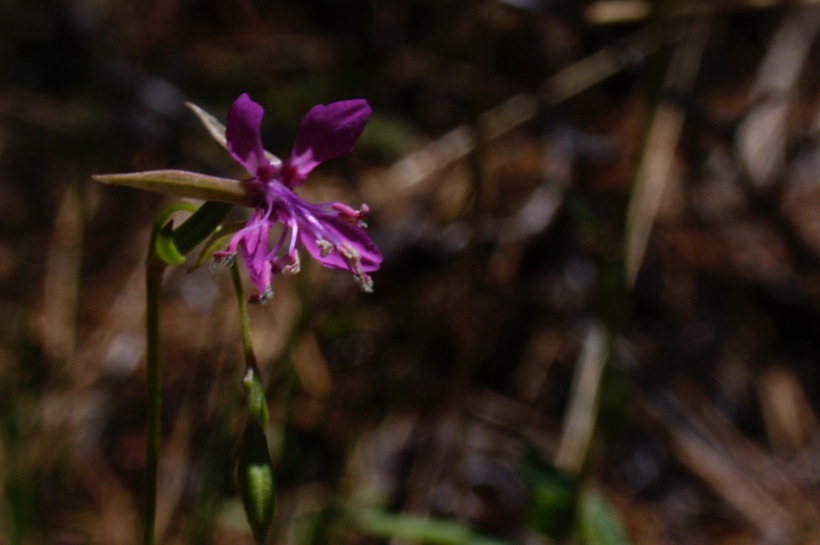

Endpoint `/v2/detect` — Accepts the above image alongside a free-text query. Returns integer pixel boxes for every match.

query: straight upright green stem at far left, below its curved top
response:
[143,259,165,545]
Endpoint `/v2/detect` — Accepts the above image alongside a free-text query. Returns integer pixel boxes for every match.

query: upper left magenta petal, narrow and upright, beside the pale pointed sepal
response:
[225,93,269,178]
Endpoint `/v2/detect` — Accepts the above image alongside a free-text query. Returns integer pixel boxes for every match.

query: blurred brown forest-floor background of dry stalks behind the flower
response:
[0,0,820,545]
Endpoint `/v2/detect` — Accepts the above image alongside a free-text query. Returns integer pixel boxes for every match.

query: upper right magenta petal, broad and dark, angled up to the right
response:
[288,99,371,187]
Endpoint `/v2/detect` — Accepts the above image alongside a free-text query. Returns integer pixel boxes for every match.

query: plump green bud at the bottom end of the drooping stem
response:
[238,421,276,544]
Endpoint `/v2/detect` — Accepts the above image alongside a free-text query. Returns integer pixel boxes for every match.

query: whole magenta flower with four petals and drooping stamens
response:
[216,94,382,301]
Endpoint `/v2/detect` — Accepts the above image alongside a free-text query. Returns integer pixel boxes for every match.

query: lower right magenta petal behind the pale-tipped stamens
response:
[299,212,382,272]
